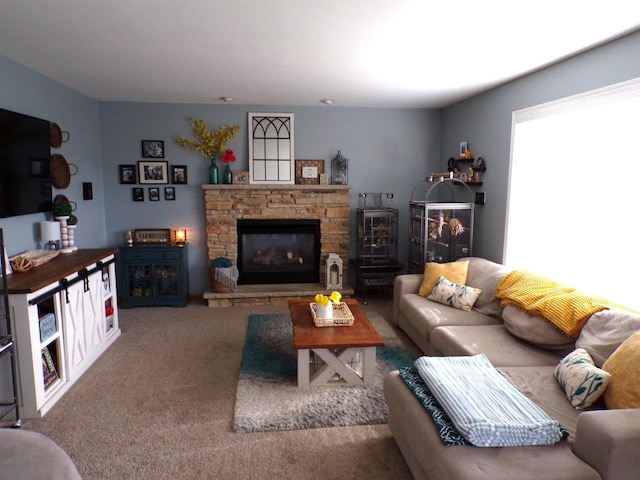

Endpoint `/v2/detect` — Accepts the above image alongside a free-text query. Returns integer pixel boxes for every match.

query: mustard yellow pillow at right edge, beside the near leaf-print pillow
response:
[602,332,640,408]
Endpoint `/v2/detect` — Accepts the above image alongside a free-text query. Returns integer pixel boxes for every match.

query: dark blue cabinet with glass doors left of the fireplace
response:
[118,244,189,308]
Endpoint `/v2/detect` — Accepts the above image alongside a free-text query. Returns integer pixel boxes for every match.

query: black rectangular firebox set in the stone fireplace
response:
[236,219,320,285]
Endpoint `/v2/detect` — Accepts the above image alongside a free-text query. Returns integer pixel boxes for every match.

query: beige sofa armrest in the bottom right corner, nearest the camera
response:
[573,408,640,480]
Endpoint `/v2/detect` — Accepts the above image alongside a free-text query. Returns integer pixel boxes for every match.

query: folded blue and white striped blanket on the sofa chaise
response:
[415,354,566,447]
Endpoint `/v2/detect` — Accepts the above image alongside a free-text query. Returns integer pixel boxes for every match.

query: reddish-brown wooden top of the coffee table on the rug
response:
[289,298,384,350]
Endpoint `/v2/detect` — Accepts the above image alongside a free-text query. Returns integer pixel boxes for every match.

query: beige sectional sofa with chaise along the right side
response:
[384,258,640,480]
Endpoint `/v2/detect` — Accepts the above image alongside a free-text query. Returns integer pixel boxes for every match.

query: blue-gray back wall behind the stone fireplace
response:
[100,103,440,294]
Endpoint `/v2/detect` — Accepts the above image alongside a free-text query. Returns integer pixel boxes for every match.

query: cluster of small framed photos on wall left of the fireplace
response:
[118,140,187,202]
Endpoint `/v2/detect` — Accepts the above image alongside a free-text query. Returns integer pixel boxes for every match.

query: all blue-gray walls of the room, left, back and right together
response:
[0,28,640,294]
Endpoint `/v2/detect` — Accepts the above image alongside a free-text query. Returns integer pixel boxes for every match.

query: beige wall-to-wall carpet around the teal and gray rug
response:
[23,302,418,480]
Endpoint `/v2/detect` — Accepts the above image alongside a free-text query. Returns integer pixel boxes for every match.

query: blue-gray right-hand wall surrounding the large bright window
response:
[440,32,640,261]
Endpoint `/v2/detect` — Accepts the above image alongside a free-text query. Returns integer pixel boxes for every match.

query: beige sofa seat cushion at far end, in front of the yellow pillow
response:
[398,293,500,339]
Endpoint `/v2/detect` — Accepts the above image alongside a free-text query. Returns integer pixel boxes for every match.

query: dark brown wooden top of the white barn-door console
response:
[7,248,119,295]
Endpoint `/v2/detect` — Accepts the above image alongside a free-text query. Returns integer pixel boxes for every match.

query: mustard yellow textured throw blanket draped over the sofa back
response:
[496,270,627,338]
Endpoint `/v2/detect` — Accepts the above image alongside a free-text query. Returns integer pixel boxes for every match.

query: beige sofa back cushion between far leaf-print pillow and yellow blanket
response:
[458,257,508,318]
